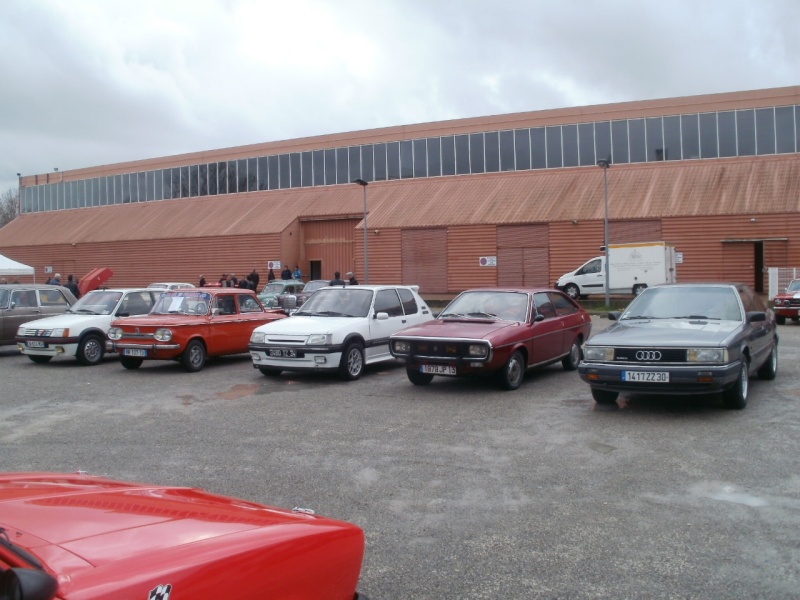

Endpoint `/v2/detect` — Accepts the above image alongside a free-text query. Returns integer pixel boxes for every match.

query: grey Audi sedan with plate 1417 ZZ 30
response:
[578,283,778,409]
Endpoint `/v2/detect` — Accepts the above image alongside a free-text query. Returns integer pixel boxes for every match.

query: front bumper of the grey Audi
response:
[578,362,740,395]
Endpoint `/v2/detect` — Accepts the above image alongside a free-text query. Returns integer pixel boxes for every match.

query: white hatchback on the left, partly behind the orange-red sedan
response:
[15,288,158,366]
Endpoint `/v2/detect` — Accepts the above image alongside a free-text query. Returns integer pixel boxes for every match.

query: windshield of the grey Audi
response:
[620,286,742,321]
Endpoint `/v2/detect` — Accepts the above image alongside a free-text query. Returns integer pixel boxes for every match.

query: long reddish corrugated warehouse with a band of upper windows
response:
[0,86,800,295]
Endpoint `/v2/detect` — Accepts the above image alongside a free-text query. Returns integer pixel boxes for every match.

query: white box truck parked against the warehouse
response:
[556,242,675,299]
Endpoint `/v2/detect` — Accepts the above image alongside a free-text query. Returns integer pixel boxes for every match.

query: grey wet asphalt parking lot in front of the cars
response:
[0,319,800,600]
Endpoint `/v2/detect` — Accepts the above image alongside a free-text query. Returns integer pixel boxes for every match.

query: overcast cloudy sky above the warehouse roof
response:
[0,0,800,193]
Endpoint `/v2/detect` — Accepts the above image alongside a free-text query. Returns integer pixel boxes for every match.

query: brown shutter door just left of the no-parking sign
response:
[402,228,446,295]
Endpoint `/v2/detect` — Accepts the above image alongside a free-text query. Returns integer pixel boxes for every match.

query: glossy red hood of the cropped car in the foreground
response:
[0,473,355,575]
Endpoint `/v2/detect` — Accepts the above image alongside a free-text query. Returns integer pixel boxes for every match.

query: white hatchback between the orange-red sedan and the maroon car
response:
[250,285,433,380]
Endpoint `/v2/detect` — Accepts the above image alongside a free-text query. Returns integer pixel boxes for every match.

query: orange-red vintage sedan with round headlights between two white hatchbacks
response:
[108,288,286,372]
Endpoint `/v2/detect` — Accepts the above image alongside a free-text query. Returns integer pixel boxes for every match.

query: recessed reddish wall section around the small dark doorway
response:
[302,219,363,279]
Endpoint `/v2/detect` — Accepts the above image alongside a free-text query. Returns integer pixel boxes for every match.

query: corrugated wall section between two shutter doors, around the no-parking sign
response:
[445,225,500,292]
